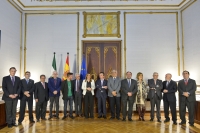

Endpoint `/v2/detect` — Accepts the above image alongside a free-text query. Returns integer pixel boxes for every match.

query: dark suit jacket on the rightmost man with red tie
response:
[178,79,197,102]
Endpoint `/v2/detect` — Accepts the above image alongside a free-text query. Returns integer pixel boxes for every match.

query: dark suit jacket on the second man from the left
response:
[20,79,35,100]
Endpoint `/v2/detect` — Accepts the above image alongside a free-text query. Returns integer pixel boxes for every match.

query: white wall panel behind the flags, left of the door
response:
[26,14,77,82]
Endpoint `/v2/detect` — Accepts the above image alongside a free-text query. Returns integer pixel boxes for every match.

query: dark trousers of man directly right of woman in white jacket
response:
[97,95,106,116]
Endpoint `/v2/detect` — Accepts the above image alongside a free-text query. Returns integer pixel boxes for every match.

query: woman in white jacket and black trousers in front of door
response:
[82,74,95,118]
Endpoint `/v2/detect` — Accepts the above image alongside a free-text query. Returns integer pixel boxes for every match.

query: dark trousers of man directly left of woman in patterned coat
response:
[122,99,134,119]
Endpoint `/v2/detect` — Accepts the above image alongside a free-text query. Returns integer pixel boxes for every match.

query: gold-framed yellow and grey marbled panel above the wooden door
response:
[83,12,121,38]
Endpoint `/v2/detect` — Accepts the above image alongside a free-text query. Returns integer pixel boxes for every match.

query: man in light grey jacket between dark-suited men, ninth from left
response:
[107,70,121,120]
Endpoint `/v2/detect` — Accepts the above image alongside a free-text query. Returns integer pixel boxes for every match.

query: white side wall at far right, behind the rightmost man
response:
[182,0,200,85]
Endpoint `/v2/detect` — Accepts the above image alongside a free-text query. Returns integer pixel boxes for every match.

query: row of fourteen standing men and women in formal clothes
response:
[2,67,196,128]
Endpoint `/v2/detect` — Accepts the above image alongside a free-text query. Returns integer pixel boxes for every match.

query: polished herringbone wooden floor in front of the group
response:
[0,113,200,133]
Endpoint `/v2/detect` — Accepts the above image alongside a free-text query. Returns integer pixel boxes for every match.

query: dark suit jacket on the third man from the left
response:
[34,82,49,102]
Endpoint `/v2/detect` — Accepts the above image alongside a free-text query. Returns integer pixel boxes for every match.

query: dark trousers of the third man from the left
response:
[36,100,47,120]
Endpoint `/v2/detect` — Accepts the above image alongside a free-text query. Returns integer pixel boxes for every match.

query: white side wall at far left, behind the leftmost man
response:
[0,0,21,86]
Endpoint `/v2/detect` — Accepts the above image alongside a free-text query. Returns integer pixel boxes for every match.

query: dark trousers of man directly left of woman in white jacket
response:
[74,93,82,115]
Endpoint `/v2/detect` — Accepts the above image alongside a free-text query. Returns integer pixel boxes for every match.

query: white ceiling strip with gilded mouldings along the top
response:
[9,0,193,11]
